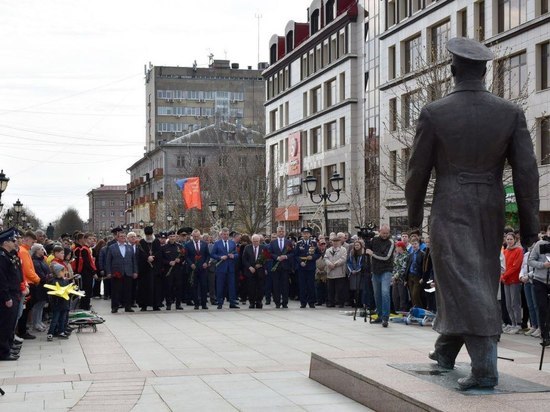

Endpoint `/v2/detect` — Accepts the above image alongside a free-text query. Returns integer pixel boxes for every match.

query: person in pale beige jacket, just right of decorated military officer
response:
[325,236,347,308]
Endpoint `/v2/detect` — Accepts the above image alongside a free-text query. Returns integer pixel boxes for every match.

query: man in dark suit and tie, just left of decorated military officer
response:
[269,226,294,309]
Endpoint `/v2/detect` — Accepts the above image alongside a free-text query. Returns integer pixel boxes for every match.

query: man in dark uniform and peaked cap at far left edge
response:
[0,228,23,360]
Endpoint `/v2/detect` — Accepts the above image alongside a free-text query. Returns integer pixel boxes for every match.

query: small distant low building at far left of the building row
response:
[87,184,126,235]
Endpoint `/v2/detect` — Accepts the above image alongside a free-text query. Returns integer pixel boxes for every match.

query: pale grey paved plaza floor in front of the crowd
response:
[0,300,550,412]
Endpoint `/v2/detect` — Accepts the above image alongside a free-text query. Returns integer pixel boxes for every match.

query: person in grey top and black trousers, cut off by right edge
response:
[527,226,550,346]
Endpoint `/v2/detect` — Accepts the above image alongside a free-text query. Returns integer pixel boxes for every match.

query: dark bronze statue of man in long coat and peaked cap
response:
[405,38,539,389]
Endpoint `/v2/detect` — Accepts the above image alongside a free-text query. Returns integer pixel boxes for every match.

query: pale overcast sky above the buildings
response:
[0,0,311,225]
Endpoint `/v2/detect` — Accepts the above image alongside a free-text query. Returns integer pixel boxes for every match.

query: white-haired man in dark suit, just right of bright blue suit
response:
[243,234,269,309]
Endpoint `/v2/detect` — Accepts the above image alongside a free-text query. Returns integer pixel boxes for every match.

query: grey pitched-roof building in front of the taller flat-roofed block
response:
[126,121,265,233]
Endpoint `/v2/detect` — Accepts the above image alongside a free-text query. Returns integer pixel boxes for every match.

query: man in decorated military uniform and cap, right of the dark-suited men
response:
[294,227,321,308]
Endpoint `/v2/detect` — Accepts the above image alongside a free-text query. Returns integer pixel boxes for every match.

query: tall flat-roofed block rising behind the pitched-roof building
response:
[144,60,264,152]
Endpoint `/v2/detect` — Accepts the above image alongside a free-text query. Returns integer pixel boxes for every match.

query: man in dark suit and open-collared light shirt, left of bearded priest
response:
[105,232,137,313]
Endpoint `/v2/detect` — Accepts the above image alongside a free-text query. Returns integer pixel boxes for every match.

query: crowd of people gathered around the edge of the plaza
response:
[0,220,550,360]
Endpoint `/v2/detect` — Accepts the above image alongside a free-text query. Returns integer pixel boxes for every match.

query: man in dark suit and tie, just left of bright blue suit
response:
[185,229,210,309]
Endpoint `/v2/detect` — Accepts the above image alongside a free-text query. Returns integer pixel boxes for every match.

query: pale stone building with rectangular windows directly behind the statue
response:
[379,0,550,231]
